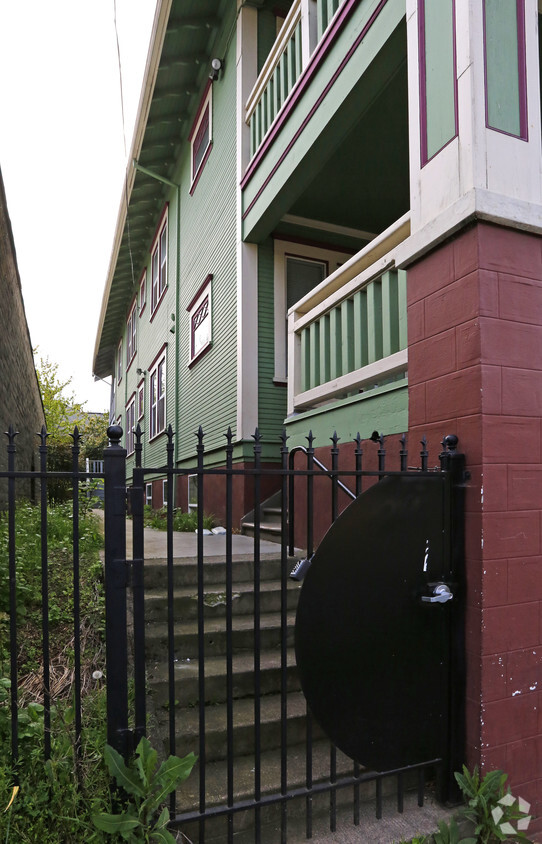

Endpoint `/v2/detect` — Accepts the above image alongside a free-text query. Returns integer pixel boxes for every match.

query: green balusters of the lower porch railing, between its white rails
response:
[299,269,407,393]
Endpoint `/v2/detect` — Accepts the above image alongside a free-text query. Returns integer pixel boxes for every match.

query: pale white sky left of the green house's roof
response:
[0,0,156,411]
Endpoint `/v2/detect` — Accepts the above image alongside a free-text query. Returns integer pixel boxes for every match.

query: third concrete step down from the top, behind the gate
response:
[145,610,295,660]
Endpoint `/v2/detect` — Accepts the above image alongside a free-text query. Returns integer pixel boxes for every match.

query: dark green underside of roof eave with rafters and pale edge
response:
[93,0,228,377]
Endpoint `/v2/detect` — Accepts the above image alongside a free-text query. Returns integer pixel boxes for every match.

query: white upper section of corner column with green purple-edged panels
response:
[407,0,542,245]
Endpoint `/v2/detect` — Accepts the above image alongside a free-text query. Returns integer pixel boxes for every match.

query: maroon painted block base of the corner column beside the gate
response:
[408,224,542,833]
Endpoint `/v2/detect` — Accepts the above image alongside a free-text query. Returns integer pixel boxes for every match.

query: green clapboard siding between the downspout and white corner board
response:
[177,34,237,460]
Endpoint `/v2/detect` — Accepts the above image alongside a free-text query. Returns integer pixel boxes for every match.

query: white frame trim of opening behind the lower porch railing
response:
[273,240,349,383]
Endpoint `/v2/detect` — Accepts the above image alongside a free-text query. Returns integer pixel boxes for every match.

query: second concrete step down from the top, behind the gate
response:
[145,580,301,622]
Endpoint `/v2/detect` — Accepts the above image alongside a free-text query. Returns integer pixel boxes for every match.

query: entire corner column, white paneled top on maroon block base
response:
[400,0,542,834]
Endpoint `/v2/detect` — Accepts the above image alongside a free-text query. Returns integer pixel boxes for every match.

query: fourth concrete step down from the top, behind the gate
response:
[147,648,300,711]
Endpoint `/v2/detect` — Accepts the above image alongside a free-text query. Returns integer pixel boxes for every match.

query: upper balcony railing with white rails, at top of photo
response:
[245,0,344,157]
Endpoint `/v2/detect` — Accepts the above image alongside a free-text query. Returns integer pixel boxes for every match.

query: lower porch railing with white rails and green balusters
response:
[288,213,410,415]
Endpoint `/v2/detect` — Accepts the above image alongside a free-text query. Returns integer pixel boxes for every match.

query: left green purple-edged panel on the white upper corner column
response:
[422,0,460,159]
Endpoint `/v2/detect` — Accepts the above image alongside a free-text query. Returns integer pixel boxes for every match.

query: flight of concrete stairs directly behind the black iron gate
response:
[145,557,382,844]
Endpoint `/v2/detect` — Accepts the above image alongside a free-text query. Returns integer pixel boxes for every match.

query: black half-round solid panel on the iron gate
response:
[296,474,449,771]
